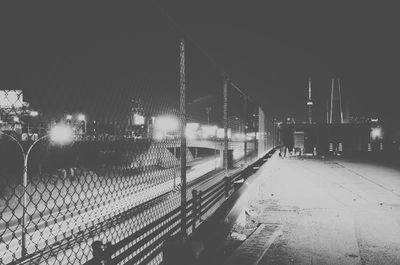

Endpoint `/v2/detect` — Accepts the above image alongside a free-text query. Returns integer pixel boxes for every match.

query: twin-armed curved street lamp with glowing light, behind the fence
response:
[0,125,73,257]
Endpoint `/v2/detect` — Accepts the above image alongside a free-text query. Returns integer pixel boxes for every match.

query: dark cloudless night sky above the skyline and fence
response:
[0,1,400,123]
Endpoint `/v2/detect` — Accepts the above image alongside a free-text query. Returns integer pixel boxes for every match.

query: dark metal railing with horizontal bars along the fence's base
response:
[86,148,272,265]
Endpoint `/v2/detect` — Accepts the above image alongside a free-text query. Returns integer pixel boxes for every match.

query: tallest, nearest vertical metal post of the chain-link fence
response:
[179,39,187,238]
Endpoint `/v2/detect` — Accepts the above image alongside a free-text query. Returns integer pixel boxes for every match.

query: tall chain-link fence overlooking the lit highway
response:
[0,3,278,264]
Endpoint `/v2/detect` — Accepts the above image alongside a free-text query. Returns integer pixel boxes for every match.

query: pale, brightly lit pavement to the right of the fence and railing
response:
[244,158,400,265]
